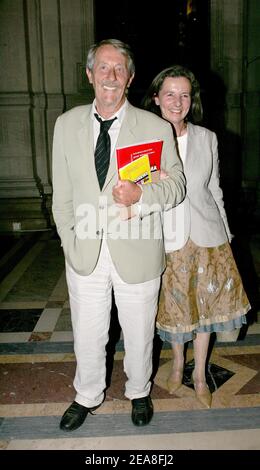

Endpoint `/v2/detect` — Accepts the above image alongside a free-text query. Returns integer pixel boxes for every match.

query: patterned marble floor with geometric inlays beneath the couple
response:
[0,231,260,451]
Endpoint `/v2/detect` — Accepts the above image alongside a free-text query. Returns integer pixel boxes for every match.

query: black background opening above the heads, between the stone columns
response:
[94,0,210,105]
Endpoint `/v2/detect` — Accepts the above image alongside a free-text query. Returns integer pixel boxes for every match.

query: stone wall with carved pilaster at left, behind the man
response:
[0,0,94,231]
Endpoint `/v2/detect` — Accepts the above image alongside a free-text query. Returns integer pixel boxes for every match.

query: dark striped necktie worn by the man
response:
[95,114,116,189]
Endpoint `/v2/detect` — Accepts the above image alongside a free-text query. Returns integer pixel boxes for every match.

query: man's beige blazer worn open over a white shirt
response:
[53,103,185,283]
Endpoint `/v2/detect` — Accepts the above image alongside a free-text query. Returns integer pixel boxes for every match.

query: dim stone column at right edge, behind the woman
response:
[210,0,260,216]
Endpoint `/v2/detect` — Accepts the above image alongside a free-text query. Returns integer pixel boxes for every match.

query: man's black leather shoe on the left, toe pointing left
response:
[60,401,100,431]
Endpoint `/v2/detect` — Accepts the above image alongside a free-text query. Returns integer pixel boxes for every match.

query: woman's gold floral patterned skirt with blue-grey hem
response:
[156,239,251,343]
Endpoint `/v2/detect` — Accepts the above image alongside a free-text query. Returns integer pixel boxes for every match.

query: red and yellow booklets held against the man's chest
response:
[116,140,163,184]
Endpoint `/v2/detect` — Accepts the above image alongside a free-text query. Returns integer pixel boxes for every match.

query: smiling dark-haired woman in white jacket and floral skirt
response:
[143,65,250,408]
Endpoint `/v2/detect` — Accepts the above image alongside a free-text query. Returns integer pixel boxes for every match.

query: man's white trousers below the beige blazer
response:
[66,241,160,407]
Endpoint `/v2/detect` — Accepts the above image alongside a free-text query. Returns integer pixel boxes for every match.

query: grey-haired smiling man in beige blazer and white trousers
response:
[53,39,185,431]
